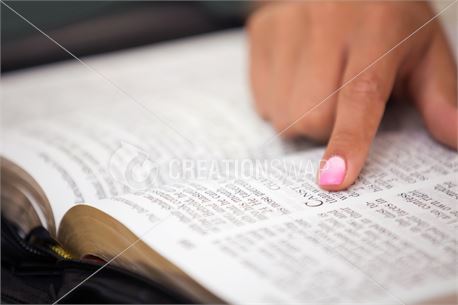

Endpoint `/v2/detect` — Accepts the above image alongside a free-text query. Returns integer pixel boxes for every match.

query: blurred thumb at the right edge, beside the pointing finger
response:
[409,32,458,149]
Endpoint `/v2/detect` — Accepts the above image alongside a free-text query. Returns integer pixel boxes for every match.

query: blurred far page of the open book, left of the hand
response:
[2,32,314,226]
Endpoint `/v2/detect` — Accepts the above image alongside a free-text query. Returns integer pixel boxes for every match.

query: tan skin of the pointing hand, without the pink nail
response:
[247,1,458,191]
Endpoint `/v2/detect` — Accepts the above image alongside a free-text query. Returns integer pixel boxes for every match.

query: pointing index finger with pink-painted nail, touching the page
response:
[318,48,399,191]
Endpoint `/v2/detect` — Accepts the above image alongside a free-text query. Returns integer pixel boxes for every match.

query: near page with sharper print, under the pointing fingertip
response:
[84,124,458,304]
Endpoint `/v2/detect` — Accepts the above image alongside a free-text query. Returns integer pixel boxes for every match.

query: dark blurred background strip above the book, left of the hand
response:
[1,1,250,73]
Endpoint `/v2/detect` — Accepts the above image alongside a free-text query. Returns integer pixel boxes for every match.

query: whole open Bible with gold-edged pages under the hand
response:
[2,32,458,304]
